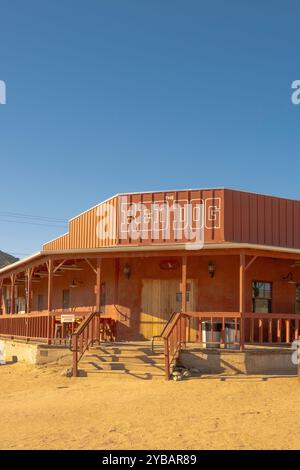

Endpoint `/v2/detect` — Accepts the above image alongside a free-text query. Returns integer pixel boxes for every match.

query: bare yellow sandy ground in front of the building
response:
[0,364,300,450]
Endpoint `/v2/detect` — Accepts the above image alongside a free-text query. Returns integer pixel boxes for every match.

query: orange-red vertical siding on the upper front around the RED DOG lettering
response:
[43,189,300,250]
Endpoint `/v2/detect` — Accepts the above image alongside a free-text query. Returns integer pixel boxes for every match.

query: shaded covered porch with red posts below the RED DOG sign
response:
[0,248,300,349]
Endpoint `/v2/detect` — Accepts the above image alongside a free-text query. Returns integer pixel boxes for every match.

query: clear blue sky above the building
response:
[0,0,300,254]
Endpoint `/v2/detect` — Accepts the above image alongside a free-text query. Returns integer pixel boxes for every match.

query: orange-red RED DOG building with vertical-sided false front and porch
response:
[0,189,300,374]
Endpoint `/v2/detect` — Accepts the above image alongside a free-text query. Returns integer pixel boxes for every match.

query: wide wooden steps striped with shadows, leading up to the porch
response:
[79,341,165,380]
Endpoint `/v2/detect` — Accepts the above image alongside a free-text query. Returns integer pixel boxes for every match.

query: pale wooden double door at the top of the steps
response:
[140,279,197,340]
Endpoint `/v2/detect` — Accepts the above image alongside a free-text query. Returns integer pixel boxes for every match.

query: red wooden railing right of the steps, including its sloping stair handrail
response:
[162,312,300,380]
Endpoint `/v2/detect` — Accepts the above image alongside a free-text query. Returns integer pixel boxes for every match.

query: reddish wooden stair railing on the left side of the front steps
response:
[71,312,116,377]
